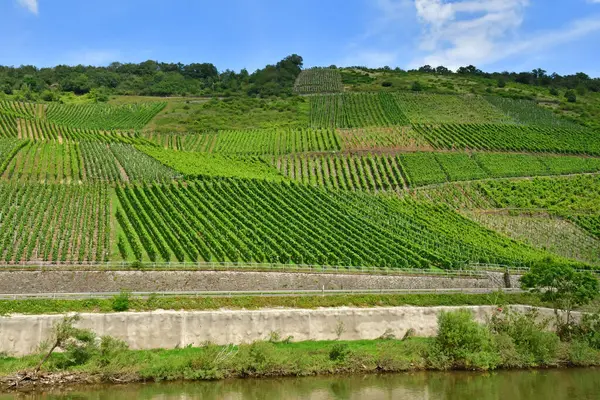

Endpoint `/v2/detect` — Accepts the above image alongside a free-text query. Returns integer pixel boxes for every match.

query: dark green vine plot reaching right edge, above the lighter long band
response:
[413,124,600,155]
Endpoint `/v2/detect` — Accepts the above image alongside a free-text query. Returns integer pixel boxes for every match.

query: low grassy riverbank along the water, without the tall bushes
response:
[0,338,600,391]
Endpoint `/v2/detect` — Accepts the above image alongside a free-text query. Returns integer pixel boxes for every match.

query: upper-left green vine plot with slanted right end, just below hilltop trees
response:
[46,102,166,130]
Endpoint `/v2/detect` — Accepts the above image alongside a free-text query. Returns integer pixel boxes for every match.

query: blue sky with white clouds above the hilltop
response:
[0,0,600,76]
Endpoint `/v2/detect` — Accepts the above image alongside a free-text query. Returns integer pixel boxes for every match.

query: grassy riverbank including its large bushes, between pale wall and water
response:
[0,310,600,388]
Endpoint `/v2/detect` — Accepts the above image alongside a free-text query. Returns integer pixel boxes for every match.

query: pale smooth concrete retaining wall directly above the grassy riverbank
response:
[0,306,552,355]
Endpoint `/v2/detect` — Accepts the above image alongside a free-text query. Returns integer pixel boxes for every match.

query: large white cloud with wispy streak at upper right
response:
[410,0,600,69]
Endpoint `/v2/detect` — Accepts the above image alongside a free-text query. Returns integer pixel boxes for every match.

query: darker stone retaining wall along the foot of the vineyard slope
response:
[0,270,518,294]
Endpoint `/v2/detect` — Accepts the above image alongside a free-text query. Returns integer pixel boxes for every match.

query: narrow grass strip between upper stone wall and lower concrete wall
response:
[0,292,548,315]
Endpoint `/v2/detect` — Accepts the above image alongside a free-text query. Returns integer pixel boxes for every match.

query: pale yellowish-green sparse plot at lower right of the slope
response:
[470,213,600,265]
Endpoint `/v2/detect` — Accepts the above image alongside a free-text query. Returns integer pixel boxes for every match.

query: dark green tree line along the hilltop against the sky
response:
[0,54,600,101]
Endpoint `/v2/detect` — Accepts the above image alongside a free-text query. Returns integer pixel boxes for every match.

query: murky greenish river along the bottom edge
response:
[0,368,600,400]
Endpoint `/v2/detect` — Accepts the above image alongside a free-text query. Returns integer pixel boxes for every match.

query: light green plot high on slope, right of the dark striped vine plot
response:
[394,93,514,124]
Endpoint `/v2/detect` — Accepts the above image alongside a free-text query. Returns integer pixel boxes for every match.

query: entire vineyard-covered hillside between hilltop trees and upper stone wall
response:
[0,69,600,269]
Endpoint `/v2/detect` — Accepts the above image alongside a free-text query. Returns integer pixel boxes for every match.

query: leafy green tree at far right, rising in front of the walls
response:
[521,259,599,328]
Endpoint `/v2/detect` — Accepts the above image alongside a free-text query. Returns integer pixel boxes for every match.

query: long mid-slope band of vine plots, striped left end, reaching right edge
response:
[271,152,600,192]
